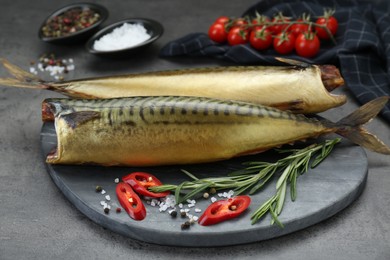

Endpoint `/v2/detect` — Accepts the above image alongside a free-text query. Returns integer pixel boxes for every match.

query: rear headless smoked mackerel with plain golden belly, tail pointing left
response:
[0,59,347,114]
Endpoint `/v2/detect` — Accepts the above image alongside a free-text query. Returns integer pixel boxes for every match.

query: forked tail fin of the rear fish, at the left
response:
[0,59,48,89]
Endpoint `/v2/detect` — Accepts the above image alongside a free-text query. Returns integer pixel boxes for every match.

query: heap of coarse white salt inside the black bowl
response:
[93,23,151,51]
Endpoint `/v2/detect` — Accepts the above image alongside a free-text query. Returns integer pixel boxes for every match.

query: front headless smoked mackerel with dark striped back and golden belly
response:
[43,96,390,166]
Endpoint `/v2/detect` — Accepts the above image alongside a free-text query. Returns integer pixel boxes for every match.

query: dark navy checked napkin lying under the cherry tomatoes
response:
[160,0,390,123]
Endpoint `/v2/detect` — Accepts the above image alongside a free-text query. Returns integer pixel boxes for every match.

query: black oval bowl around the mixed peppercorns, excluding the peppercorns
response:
[38,3,108,44]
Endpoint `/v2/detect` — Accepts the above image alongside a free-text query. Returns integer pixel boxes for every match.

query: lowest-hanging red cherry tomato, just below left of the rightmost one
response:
[295,33,320,58]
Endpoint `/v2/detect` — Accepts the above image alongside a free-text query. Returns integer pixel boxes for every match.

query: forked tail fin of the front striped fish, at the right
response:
[335,96,390,154]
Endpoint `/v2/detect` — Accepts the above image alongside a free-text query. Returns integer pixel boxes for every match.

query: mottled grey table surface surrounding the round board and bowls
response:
[0,0,390,260]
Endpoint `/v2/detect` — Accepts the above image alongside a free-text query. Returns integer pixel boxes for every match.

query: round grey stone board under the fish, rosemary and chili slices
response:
[41,123,368,247]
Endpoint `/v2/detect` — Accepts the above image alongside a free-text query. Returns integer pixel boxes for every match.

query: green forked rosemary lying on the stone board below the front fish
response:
[149,138,341,224]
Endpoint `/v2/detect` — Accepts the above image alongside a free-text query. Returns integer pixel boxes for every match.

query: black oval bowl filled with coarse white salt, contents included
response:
[86,18,164,57]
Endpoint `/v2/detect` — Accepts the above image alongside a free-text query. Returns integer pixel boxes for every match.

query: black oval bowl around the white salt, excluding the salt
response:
[86,18,164,58]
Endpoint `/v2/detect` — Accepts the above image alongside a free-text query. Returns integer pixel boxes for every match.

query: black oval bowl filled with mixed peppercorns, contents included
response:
[38,3,108,44]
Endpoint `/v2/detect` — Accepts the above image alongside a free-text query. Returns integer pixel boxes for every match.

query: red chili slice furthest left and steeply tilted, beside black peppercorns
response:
[116,182,146,220]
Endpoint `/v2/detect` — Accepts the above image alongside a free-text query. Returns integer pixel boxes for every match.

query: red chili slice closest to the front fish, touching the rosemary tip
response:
[122,172,170,198]
